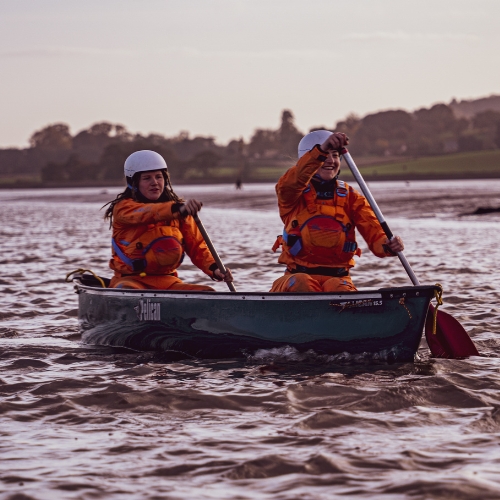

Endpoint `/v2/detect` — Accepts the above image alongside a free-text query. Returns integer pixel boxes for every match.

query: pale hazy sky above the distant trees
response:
[0,0,500,148]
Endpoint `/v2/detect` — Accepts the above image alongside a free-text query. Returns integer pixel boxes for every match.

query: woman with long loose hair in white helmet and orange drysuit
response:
[104,150,233,291]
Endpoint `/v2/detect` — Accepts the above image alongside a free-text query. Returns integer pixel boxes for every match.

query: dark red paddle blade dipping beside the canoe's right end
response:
[425,304,479,359]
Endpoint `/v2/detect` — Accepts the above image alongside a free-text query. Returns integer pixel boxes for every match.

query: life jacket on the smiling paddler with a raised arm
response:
[273,180,361,266]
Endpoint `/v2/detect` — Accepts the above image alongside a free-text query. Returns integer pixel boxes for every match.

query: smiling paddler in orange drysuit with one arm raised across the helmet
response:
[271,130,404,292]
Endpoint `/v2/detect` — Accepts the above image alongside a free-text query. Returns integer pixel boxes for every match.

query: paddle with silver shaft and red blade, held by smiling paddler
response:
[340,148,479,358]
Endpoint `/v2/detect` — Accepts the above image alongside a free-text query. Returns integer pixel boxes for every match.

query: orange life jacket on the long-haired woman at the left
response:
[111,222,184,274]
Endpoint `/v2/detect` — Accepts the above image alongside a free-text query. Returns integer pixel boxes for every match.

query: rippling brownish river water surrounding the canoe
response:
[0,180,500,500]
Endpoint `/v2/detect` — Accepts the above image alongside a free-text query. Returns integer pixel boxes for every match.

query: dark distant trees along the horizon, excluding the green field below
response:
[0,96,500,183]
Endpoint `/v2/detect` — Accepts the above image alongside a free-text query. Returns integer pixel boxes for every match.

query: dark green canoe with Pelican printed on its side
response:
[73,274,436,361]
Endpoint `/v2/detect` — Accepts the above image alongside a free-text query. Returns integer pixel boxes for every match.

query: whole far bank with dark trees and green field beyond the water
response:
[0,95,500,189]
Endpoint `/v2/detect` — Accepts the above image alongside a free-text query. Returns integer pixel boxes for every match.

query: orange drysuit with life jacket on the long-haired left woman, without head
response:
[109,198,217,291]
